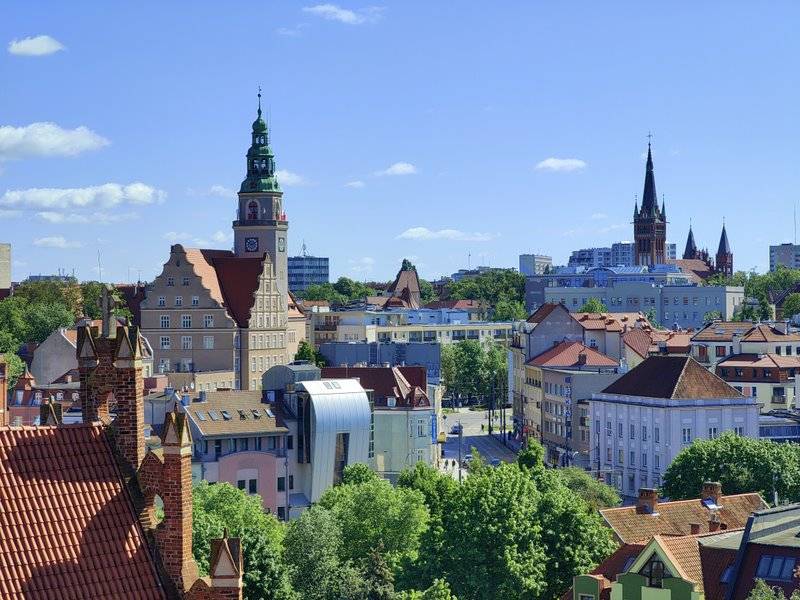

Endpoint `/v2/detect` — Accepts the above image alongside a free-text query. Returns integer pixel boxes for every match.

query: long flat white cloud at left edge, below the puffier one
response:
[0,182,167,210]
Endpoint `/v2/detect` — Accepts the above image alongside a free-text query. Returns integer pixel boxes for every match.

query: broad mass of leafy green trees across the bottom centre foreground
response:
[193,444,615,600]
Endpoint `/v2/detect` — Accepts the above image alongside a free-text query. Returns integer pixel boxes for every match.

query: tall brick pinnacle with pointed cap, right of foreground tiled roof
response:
[155,407,197,594]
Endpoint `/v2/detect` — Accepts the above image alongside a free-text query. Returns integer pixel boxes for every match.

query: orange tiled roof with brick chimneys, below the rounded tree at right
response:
[600,493,766,544]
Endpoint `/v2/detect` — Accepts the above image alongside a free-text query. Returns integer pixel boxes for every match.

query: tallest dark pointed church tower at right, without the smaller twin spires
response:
[633,142,667,266]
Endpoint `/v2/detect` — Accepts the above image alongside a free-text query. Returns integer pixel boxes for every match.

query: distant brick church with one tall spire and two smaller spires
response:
[633,142,733,280]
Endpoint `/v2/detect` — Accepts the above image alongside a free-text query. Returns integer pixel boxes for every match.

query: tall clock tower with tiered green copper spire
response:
[233,92,289,310]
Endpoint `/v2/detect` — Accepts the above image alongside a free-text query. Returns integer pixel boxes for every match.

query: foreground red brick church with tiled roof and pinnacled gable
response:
[0,290,243,600]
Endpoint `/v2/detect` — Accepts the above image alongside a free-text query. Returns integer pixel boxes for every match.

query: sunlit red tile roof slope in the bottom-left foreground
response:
[0,424,164,600]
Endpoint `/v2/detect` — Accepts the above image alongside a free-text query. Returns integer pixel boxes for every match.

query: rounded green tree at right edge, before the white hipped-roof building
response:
[662,433,800,502]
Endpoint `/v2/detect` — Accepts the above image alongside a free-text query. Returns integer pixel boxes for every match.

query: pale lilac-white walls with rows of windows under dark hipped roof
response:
[590,394,758,497]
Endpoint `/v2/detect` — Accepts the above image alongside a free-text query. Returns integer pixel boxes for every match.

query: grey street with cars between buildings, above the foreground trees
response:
[443,408,516,478]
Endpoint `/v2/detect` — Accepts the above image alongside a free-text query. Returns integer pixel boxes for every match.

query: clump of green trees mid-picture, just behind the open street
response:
[441,340,508,401]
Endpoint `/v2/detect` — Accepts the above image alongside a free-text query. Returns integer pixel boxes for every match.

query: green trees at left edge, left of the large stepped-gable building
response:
[0,280,130,388]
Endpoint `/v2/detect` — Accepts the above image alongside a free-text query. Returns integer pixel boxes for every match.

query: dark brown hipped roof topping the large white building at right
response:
[603,356,743,399]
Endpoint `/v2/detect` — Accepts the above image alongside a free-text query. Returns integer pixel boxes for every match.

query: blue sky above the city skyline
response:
[0,0,800,281]
